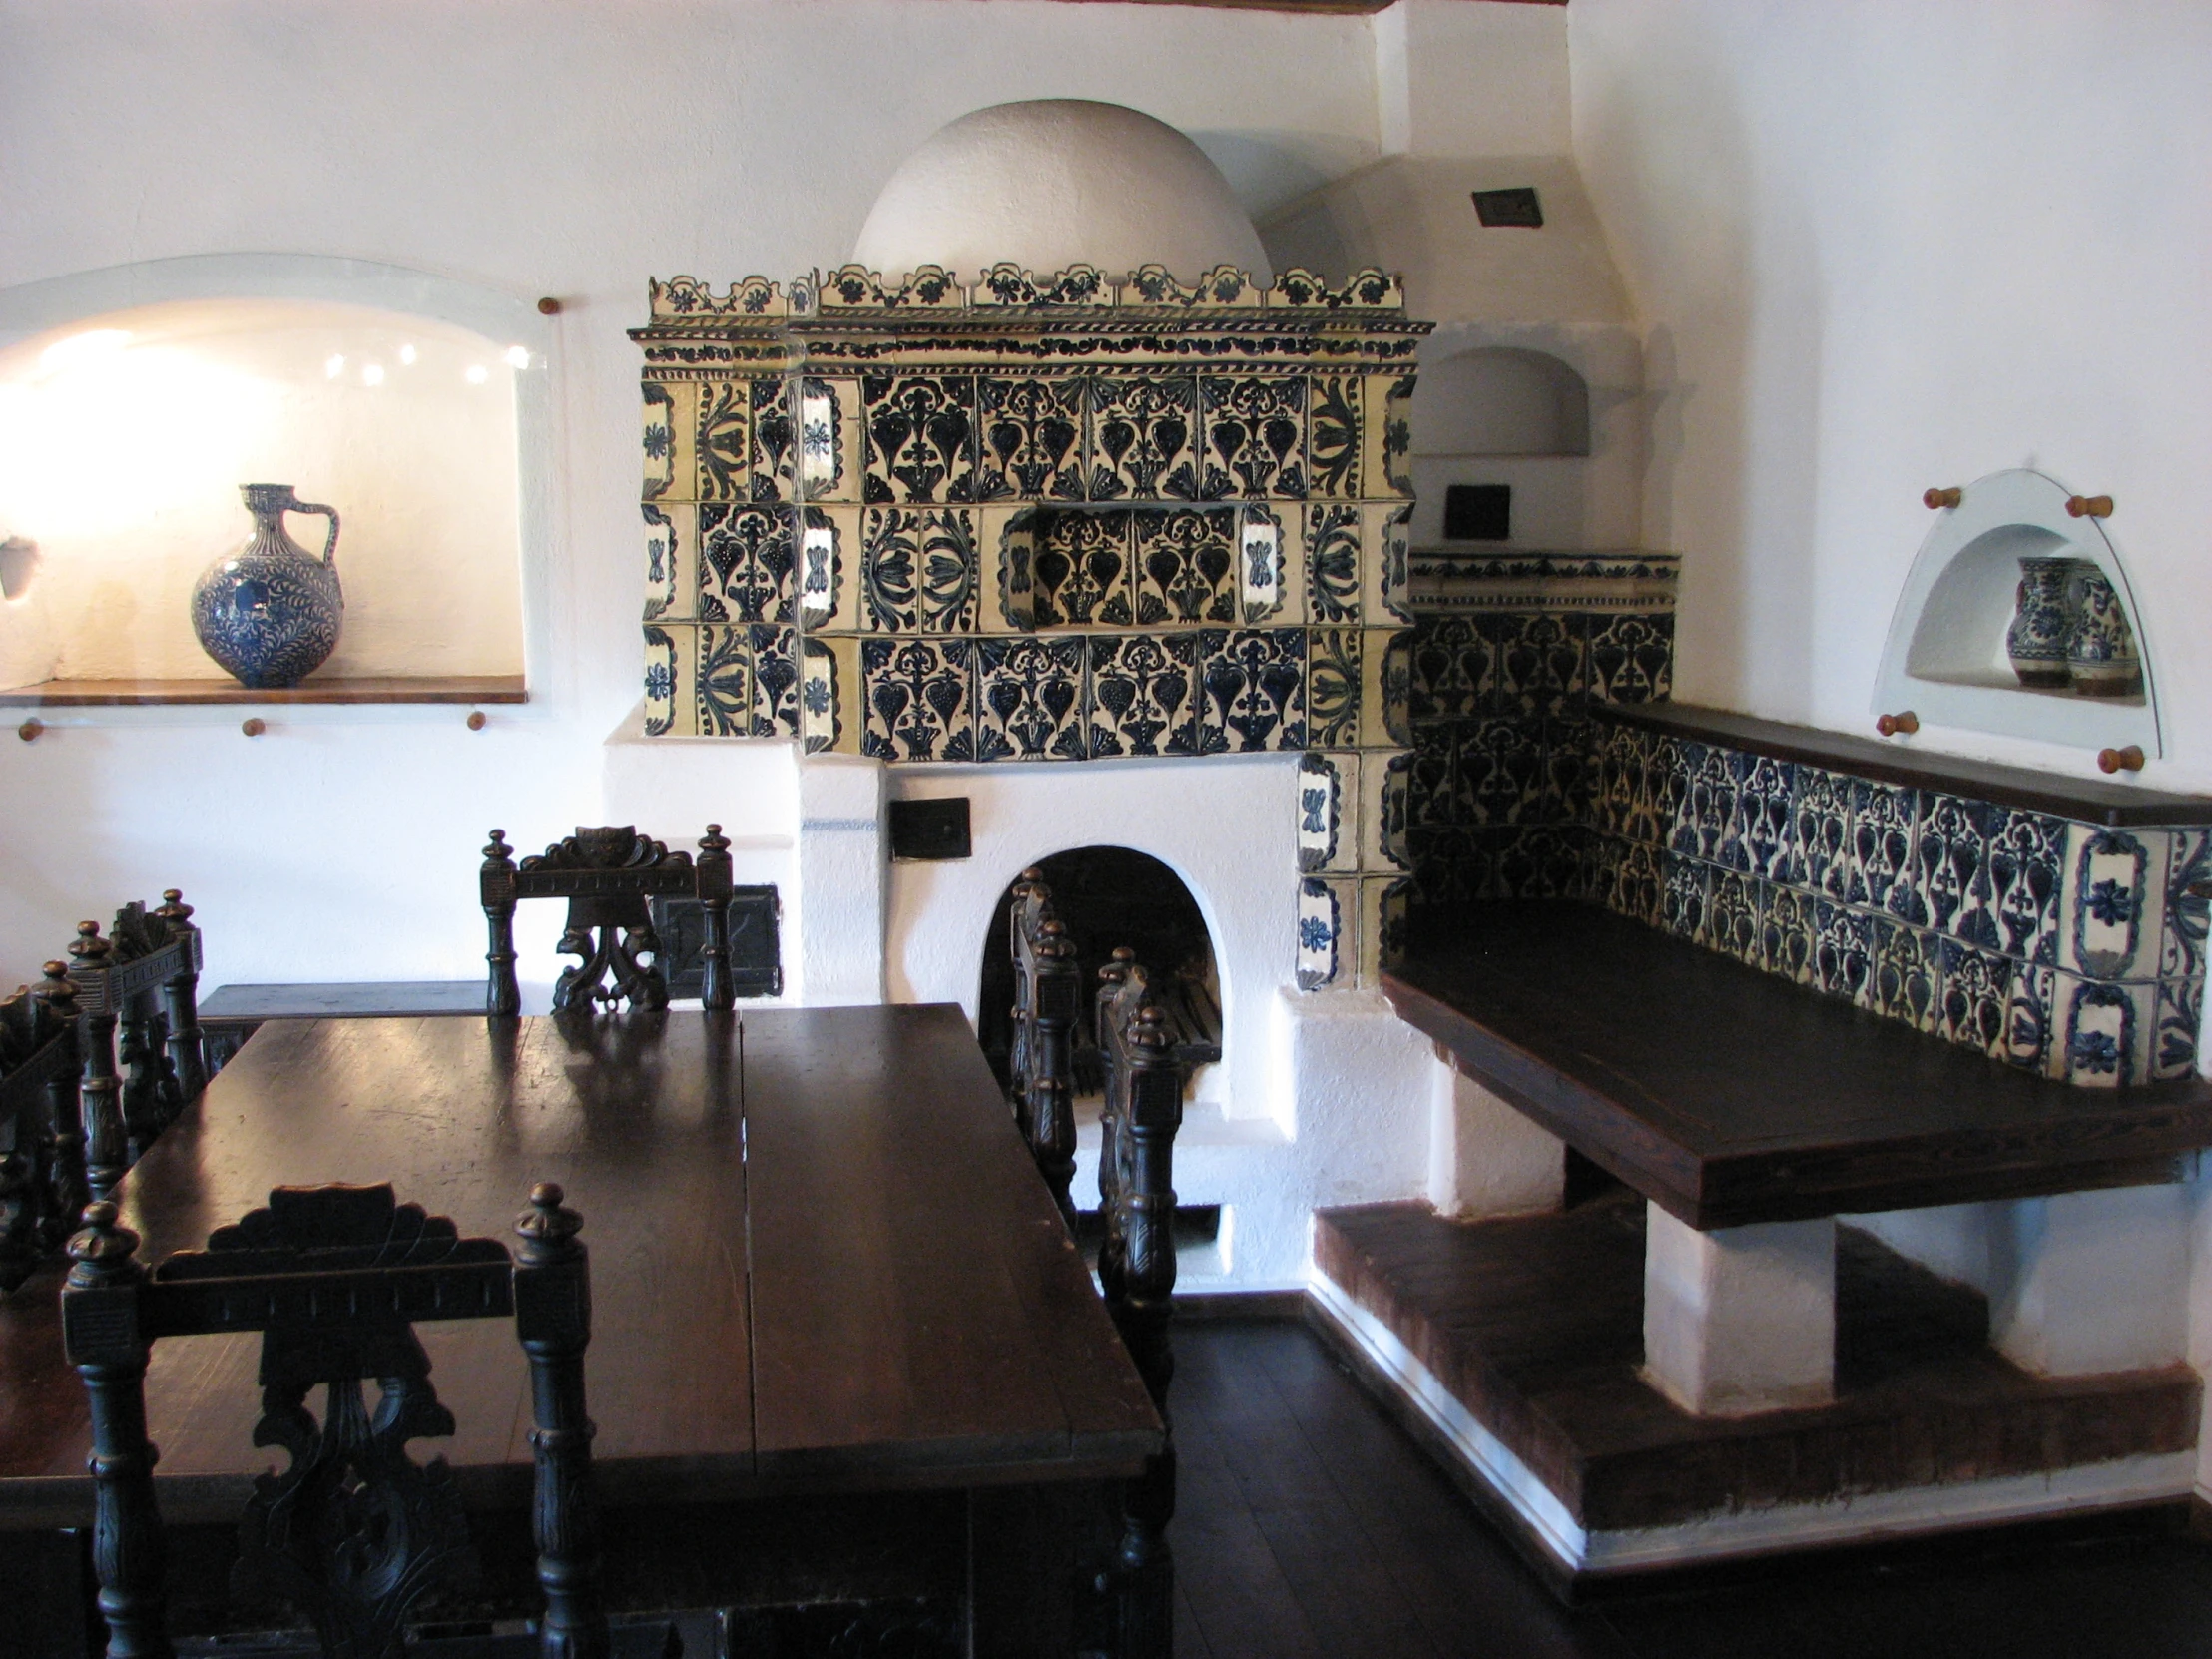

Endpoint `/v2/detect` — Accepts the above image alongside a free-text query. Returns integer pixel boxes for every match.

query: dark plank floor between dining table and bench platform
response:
[1170,1321,2212,1659]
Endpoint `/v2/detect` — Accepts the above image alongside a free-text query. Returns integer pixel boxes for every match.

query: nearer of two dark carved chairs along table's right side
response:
[1095,949,1190,1659]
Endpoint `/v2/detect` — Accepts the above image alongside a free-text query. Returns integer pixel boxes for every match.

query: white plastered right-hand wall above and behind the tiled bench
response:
[1566,0,2212,1491]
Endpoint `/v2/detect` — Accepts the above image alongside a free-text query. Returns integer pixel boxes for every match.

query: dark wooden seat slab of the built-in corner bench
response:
[1382,900,2212,1228]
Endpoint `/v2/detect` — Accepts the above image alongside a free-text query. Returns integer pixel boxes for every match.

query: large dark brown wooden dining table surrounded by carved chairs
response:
[0,1004,1164,1652]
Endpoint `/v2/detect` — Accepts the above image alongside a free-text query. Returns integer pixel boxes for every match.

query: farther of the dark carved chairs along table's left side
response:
[69,887,208,1199]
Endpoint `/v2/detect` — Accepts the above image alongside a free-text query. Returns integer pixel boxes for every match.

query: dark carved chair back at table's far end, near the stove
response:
[478,823,737,1015]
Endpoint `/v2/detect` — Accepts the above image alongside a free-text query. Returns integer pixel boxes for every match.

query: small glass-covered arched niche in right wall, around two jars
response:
[1874,467,2163,755]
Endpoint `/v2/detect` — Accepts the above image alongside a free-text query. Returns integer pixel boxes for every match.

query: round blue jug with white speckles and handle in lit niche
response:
[193,484,345,690]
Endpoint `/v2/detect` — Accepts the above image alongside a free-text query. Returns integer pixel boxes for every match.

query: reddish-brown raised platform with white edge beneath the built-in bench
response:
[1314,1192,2199,1577]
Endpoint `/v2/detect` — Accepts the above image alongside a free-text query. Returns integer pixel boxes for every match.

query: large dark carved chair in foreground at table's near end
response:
[62,1186,608,1659]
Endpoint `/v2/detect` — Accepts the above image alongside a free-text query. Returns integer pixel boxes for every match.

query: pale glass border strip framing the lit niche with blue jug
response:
[0,255,557,726]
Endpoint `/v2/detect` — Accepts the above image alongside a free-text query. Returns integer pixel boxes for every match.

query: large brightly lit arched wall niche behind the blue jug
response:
[0,255,551,724]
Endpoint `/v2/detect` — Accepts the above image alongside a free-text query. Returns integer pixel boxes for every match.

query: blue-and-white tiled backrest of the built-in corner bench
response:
[1409,555,2212,1086]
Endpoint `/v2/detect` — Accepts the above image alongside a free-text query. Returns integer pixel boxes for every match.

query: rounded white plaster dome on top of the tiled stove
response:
[851,98,1274,287]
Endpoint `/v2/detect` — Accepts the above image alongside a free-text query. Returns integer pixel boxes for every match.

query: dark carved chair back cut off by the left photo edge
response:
[0,962,86,1290]
